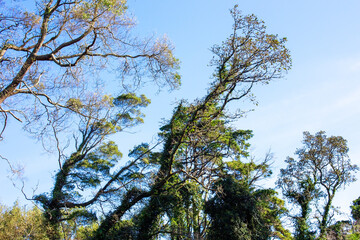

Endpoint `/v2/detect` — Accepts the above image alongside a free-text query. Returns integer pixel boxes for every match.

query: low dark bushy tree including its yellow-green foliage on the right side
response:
[205,176,291,240]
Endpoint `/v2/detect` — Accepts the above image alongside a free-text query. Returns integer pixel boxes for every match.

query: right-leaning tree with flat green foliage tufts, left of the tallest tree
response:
[33,94,149,239]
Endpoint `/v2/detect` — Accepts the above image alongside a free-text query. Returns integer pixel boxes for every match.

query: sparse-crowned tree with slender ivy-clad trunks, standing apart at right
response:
[277,131,358,239]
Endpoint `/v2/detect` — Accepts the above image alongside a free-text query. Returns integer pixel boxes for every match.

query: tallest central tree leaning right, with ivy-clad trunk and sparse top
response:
[94,5,290,239]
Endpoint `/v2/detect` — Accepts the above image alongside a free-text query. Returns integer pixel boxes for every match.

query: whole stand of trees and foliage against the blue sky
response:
[0,0,360,240]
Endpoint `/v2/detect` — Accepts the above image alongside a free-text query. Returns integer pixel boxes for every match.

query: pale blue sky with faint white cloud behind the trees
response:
[0,0,360,220]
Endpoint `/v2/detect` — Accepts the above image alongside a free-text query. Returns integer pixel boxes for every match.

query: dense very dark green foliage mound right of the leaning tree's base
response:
[205,177,271,240]
